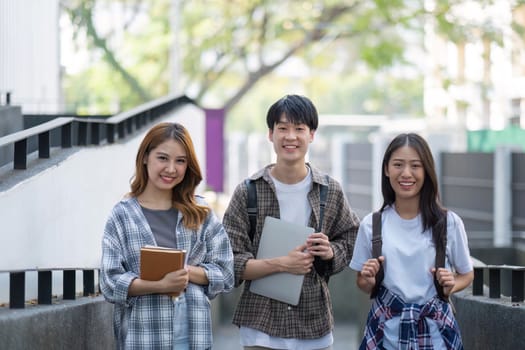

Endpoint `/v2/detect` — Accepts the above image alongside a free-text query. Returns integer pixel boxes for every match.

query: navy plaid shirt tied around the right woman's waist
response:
[359,287,463,350]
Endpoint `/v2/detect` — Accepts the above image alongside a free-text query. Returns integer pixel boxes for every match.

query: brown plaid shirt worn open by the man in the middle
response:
[223,165,359,339]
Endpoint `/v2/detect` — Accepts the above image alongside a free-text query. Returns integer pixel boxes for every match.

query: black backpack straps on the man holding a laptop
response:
[244,175,330,283]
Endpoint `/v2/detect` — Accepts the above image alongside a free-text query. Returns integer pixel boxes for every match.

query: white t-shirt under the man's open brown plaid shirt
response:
[240,168,333,350]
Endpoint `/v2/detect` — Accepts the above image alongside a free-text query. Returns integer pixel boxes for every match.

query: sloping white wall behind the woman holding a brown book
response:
[0,104,206,303]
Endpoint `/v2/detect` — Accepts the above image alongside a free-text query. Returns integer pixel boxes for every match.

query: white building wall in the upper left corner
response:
[0,0,62,113]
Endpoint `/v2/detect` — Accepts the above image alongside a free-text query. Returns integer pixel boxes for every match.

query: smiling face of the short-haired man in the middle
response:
[268,114,315,163]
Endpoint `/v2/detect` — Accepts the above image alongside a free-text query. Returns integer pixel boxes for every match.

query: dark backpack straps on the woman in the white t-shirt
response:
[370,211,449,302]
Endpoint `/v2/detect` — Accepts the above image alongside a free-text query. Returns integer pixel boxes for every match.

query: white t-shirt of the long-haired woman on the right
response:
[349,207,473,349]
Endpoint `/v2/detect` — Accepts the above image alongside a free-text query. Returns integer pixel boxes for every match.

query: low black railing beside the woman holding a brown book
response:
[0,267,99,309]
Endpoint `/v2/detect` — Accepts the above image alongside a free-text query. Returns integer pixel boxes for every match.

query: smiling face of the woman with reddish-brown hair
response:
[145,139,188,194]
